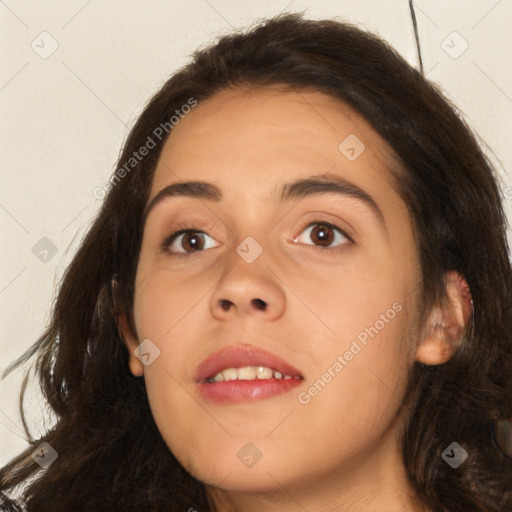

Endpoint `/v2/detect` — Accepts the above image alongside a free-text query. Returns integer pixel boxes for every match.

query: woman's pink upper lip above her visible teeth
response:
[196,345,302,382]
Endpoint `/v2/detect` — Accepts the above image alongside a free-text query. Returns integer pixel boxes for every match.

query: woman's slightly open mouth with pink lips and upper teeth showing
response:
[196,345,304,404]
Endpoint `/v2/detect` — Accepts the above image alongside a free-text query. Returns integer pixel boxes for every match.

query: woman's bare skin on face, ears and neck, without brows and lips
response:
[121,88,467,512]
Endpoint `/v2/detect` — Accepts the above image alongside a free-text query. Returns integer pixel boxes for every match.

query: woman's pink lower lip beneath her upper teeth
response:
[199,379,302,404]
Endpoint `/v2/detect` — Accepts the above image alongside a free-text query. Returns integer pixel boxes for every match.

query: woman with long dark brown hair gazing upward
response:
[1,15,512,512]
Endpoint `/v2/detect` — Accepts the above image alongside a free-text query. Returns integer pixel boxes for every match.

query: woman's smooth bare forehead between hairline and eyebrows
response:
[150,87,397,199]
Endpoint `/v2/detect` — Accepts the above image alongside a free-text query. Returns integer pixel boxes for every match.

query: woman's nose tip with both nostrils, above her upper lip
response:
[210,253,286,320]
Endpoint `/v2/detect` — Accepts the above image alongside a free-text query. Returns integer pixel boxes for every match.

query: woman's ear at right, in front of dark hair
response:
[416,271,473,365]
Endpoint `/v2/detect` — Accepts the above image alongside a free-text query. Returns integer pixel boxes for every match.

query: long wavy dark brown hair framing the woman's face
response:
[0,14,512,512]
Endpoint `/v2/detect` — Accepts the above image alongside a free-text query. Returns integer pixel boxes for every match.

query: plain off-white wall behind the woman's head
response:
[0,0,512,465]
